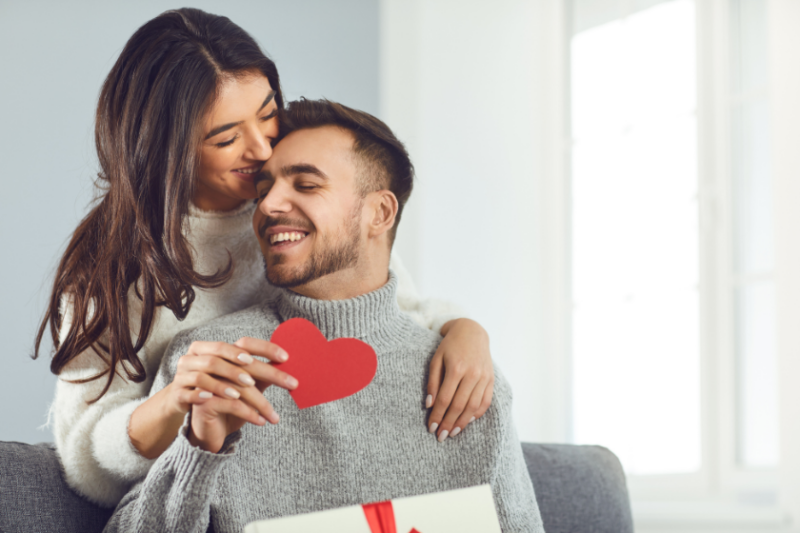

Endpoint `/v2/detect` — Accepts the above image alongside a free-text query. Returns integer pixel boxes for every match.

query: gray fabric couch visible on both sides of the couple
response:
[0,442,633,533]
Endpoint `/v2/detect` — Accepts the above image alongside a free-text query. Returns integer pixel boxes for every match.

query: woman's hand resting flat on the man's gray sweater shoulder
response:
[425,318,494,442]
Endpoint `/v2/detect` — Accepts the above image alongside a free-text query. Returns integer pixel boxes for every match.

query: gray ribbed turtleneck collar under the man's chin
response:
[273,270,400,340]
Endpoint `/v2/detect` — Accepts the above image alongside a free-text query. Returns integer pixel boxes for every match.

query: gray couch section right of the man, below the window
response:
[522,442,633,533]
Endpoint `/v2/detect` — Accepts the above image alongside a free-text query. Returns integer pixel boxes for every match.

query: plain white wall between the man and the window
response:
[380,0,566,441]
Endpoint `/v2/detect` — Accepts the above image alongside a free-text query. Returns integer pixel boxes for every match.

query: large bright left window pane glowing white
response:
[571,0,701,474]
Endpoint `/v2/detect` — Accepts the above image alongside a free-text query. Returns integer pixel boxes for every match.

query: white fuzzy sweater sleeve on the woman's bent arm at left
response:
[50,296,158,507]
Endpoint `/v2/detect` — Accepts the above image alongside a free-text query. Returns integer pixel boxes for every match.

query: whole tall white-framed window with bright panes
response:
[568,0,783,530]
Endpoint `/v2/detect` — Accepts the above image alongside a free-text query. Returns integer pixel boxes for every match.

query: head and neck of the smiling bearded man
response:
[253,103,413,300]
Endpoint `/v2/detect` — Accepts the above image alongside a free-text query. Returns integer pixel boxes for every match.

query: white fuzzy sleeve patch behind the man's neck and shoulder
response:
[389,253,467,333]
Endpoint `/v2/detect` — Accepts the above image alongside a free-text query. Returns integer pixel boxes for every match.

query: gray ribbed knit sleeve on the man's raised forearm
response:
[103,415,241,533]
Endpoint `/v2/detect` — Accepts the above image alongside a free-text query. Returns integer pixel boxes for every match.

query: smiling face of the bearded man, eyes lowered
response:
[253,126,363,287]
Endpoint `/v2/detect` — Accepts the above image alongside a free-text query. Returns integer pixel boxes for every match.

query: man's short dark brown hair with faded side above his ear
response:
[278,98,414,241]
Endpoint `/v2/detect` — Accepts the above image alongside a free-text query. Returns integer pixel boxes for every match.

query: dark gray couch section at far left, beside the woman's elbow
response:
[0,442,113,533]
